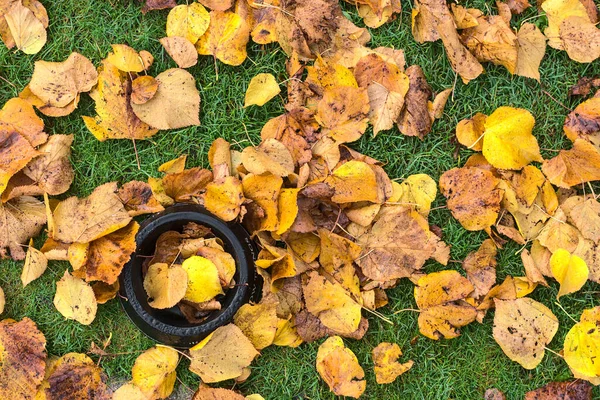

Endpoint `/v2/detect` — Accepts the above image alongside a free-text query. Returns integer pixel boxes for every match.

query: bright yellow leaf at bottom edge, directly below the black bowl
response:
[131,346,179,399]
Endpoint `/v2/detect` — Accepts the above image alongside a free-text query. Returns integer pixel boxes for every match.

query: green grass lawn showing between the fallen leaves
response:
[0,0,600,399]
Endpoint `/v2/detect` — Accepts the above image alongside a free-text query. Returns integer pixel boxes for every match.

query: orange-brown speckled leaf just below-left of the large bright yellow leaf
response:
[440,167,503,231]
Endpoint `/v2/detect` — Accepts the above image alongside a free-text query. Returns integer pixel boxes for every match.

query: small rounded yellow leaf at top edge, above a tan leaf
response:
[167,2,211,44]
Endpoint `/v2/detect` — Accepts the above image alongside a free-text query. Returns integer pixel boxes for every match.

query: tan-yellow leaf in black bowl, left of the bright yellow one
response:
[144,263,188,309]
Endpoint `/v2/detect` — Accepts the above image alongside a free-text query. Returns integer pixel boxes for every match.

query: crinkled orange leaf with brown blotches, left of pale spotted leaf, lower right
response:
[415,270,477,340]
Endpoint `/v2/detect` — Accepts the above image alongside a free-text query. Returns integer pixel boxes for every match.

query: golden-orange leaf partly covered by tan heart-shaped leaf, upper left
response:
[82,61,158,141]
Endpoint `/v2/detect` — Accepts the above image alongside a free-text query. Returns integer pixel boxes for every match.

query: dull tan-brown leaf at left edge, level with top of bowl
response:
[0,196,46,260]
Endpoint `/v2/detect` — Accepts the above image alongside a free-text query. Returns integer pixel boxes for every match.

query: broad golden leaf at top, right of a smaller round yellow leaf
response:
[196,10,250,66]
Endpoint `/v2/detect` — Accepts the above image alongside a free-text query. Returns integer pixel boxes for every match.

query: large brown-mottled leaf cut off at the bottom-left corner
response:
[0,318,46,400]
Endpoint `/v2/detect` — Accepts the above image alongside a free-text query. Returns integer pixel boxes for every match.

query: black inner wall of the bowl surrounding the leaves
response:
[131,214,248,327]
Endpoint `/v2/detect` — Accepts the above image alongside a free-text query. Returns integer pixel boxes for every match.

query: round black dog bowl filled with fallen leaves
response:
[119,204,262,348]
